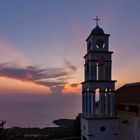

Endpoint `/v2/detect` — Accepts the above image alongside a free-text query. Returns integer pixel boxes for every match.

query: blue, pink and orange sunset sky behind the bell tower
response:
[0,0,140,127]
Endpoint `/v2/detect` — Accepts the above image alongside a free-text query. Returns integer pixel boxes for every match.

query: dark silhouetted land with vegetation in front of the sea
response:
[0,115,80,140]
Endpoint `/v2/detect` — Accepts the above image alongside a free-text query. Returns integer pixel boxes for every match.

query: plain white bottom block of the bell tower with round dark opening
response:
[81,118,119,140]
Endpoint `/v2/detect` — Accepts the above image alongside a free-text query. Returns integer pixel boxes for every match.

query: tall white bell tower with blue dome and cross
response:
[81,17,119,140]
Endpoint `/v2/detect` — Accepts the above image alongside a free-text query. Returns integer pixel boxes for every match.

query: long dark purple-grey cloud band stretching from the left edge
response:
[0,63,69,87]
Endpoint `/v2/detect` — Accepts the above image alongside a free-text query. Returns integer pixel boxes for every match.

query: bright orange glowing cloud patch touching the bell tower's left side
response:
[62,83,81,93]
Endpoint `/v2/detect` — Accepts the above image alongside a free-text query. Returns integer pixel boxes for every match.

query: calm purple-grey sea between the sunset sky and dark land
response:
[0,94,81,128]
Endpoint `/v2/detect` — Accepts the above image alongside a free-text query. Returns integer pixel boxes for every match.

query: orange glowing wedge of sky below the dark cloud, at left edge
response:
[0,77,51,94]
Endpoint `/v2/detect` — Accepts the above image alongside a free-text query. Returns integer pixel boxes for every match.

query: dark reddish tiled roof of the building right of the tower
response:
[116,82,140,104]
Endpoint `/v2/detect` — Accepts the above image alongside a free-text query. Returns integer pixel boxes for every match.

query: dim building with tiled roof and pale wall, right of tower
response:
[116,82,140,140]
